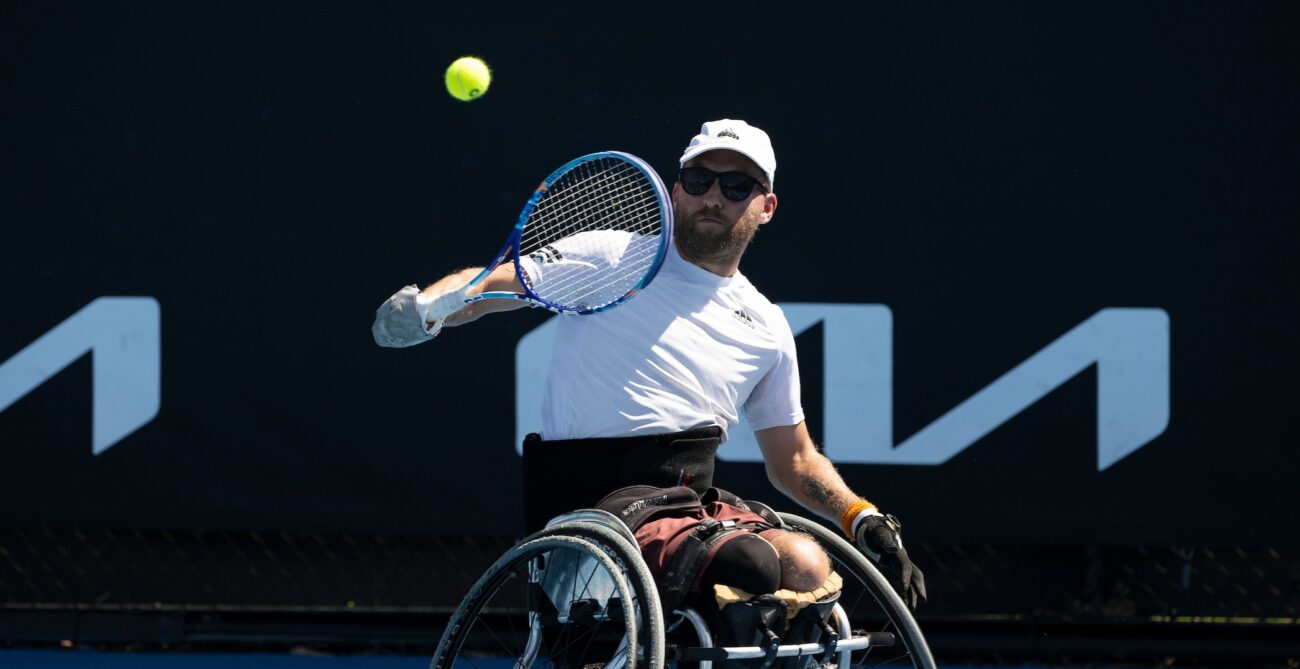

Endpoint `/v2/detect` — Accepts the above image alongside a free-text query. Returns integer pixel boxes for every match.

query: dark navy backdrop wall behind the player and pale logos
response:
[0,3,1300,543]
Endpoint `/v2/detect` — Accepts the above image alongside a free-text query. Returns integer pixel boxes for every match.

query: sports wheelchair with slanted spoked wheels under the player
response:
[430,503,935,669]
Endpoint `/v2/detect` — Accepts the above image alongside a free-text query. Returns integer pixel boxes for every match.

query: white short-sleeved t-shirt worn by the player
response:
[520,242,803,439]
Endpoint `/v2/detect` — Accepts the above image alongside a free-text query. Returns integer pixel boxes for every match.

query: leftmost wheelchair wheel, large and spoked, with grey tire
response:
[429,536,637,669]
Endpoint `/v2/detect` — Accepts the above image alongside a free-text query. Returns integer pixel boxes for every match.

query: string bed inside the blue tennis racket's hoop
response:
[520,158,663,308]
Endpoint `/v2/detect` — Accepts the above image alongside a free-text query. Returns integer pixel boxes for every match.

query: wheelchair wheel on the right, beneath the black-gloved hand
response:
[779,513,935,669]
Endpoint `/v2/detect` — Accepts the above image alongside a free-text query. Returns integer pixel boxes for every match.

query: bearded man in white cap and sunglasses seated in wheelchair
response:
[374,120,926,664]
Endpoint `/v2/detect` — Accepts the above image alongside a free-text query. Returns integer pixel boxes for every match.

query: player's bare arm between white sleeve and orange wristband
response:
[754,422,861,526]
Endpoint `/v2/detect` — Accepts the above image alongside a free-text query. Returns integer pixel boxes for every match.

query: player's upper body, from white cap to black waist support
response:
[373,118,926,607]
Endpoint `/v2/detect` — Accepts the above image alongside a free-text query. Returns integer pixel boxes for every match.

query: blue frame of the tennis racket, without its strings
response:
[464,151,672,316]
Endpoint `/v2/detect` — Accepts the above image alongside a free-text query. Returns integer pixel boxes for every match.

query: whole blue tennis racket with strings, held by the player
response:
[428,151,672,321]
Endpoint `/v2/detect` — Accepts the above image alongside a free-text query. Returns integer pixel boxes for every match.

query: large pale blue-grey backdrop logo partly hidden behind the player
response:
[515,303,1169,472]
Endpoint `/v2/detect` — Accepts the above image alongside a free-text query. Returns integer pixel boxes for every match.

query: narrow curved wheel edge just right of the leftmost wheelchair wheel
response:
[532,521,664,669]
